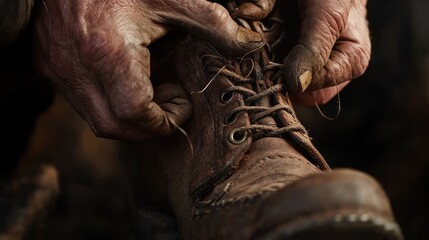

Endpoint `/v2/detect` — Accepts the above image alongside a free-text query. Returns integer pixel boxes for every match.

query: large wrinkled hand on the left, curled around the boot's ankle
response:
[35,0,262,139]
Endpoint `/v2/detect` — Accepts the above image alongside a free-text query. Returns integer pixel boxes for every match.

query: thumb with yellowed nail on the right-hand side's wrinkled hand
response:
[284,0,351,93]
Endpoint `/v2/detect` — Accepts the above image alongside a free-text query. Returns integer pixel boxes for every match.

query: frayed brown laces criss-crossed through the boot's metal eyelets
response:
[203,45,307,144]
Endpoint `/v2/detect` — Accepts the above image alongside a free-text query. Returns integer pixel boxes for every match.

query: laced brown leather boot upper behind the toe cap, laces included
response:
[154,19,329,239]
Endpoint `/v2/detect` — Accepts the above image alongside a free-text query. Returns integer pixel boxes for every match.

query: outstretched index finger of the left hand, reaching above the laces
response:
[161,0,263,54]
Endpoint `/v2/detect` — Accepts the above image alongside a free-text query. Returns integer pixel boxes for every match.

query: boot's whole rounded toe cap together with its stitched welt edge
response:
[251,169,402,239]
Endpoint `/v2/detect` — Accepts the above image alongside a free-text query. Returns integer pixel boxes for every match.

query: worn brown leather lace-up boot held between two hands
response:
[144,17,402,240]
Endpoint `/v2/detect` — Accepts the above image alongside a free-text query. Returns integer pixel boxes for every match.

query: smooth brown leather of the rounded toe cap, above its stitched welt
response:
[254,169,393,231]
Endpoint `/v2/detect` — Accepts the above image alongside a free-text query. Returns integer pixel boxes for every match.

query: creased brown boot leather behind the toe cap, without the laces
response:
[145,19,329,239]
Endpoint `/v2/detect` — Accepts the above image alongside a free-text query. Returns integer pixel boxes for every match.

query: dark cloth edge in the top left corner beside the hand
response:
[0,0,34,49]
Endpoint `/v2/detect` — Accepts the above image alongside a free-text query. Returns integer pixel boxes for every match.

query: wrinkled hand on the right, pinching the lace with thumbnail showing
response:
[229,0,371,105]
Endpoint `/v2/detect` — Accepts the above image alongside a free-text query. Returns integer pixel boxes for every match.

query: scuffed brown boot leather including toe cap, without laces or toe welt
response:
[144,31,400,240]
